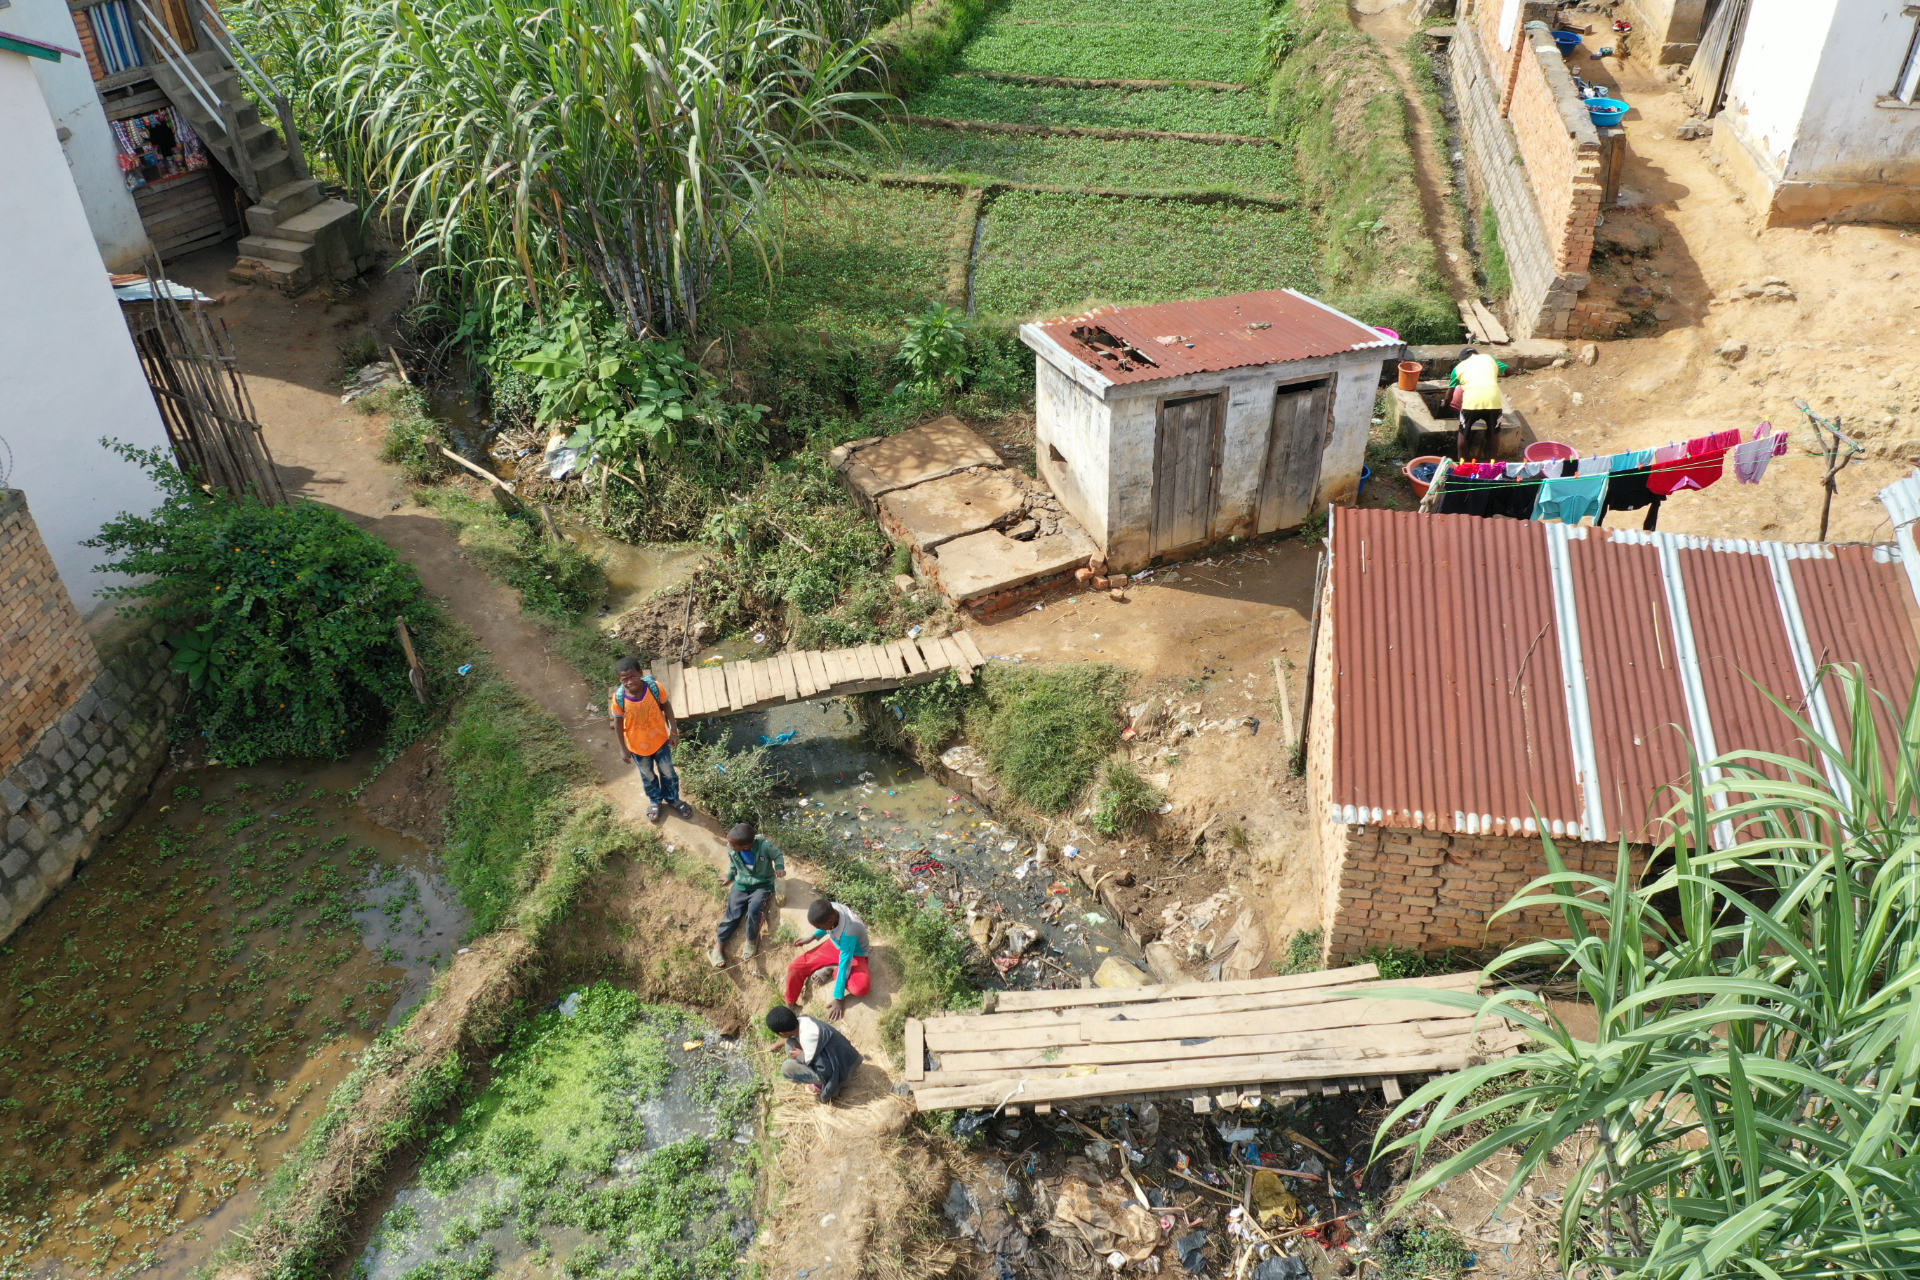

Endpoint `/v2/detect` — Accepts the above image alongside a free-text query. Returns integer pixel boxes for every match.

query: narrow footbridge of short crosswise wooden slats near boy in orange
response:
[647,631,987,720]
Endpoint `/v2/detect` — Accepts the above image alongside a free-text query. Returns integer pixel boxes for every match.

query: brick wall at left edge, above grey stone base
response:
[0,489,100,773]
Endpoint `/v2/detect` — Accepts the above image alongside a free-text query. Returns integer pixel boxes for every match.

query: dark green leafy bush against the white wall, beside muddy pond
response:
[86,443,436,764]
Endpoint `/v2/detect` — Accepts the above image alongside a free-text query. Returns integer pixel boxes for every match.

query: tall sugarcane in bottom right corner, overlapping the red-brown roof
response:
[1380,670,1920,1280]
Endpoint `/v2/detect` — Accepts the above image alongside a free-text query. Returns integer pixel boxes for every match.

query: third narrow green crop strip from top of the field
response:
[876,129,1298,198]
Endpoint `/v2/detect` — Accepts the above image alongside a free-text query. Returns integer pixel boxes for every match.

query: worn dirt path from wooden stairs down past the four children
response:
[169,246,906,1280]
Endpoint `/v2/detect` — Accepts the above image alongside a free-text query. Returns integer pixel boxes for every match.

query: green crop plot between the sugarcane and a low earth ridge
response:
[712,182,960,340]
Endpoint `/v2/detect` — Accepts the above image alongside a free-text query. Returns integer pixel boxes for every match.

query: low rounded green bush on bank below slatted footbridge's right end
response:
[968,662,1127,814]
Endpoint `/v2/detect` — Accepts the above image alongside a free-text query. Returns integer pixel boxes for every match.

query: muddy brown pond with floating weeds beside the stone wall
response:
[0,758,465,1280]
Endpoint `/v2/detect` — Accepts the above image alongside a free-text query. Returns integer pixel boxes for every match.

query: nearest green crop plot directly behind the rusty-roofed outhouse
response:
[973,192,1319,317]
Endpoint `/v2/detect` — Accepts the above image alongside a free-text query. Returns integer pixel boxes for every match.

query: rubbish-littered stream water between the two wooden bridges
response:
[699,699,1144,974]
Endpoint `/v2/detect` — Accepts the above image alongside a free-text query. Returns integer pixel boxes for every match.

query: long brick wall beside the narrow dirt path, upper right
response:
[1448,17,1601,338]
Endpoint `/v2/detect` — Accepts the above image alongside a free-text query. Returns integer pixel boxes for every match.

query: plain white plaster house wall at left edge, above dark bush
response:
[0,52,167,616]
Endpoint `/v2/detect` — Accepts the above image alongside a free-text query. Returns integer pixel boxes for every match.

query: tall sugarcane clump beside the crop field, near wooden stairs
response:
[246,0,883,338]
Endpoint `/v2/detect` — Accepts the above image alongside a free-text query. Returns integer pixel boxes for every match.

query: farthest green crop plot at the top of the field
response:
[960,19,1260,84]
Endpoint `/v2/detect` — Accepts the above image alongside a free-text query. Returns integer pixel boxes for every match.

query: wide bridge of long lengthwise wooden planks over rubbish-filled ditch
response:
[906,965,1524,1111]
